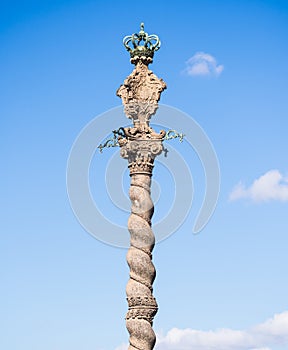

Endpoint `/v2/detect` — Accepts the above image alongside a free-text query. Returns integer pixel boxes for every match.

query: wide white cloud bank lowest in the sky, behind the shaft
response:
[116,311,288,350]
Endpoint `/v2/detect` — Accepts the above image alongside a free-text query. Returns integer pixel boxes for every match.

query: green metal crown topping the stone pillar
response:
[123,22,161,65]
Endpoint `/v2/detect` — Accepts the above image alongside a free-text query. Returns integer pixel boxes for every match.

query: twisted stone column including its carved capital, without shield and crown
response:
[119,135,165,350]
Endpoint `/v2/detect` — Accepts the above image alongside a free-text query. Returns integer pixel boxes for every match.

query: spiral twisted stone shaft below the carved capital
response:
[126,174,157,350]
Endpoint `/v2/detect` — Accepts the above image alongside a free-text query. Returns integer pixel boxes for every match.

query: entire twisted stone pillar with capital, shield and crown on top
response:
[117,24,166,350]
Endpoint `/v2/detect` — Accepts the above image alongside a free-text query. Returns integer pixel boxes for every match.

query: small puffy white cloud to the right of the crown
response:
[185,52,224,76]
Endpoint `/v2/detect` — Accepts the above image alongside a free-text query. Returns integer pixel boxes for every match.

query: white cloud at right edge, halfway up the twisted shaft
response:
[229,170,288,202]
